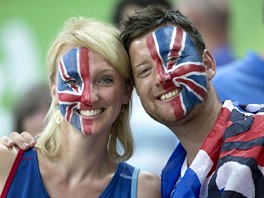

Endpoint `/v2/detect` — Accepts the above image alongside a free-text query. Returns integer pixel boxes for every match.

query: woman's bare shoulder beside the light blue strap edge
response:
[137,170,161,198]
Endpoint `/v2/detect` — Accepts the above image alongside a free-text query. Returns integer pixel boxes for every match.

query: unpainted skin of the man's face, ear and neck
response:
[129,26,221,164]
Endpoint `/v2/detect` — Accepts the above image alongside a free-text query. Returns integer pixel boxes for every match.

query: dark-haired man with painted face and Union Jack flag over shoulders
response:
[121,7,264,197]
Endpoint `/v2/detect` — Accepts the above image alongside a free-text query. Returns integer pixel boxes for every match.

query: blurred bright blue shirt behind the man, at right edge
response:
[212,51,264,104]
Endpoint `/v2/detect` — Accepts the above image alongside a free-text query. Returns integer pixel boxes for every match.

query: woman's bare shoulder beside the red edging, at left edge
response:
[0,144,18,192]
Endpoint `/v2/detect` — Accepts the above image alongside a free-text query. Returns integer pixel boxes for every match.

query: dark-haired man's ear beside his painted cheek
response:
[203,49,216,80]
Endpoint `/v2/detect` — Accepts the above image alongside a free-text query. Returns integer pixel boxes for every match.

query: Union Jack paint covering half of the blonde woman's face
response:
[58,48,92,135]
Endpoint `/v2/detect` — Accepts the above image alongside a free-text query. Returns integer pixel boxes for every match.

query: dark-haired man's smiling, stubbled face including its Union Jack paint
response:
[129,26,207,123]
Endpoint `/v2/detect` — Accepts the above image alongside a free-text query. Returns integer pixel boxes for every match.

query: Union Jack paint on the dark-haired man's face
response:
[146,26,207,119]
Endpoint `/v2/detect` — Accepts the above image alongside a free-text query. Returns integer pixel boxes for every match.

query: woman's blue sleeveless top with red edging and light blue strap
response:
[1,149,139,198]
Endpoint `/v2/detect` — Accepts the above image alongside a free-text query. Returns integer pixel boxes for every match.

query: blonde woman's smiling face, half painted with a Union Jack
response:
[55,48,130,135]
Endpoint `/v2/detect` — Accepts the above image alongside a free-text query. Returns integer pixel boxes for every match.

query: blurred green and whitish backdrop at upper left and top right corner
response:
[0,0,264,133]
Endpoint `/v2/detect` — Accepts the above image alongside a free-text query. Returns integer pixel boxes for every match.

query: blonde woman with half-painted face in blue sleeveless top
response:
[0,18,160,198]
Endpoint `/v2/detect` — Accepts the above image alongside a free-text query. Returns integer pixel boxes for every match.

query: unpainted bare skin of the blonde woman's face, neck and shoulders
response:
[0,50,160,198]
